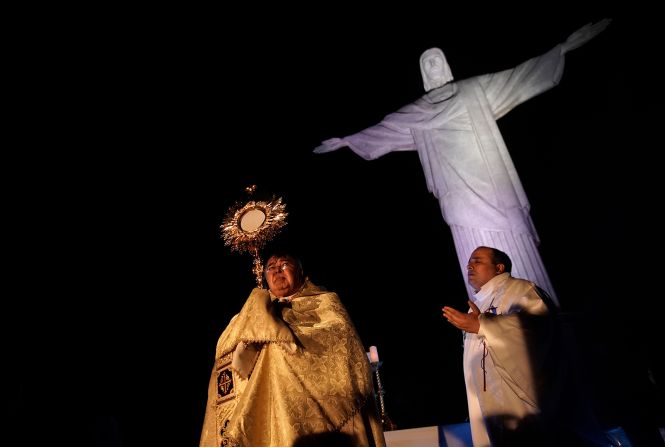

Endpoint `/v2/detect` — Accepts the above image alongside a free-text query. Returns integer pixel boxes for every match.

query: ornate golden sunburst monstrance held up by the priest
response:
[220,185,288,288]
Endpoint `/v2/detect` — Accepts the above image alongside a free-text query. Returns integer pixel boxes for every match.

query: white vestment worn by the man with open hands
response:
[463,273,554,447]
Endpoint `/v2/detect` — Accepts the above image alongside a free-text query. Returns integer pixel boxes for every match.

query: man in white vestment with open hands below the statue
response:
[442,246,606,447]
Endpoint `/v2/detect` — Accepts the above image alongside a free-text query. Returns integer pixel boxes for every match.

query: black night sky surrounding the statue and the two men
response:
[10,7,665,446]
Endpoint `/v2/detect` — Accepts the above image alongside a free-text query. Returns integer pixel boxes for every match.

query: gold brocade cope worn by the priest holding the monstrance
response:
[200,281,385,447]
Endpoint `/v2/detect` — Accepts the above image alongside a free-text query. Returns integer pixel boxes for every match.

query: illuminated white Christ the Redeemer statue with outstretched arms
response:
[314,19,610,303]
